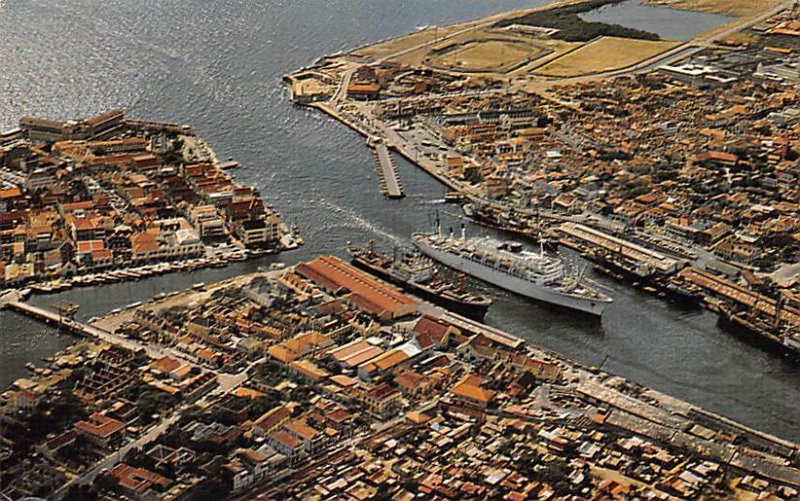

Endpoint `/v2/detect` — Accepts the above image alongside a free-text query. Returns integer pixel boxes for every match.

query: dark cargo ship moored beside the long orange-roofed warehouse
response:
[347,242,492,321]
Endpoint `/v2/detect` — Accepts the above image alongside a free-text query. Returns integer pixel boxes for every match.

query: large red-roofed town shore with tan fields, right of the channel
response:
[286,0,800,355]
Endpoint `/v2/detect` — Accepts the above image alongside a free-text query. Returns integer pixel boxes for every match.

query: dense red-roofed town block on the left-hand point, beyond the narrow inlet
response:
[0,111,302,293]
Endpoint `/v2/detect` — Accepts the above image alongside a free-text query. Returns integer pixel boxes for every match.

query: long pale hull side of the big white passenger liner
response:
[414,240,610,316]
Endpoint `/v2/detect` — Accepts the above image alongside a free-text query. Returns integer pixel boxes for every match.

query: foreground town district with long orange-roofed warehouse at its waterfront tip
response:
[0,256,800,499]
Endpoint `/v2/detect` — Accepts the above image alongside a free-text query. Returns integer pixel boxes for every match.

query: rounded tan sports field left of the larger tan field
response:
[430,40,542,73]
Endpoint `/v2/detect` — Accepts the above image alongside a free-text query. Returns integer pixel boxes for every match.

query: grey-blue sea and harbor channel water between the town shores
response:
[0,0,800,441]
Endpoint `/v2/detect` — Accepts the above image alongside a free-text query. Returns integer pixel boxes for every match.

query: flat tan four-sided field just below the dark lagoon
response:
[536,37,678,77]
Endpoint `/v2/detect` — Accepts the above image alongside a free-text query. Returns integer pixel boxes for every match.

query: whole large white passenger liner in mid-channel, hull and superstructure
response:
[411,232,612,316]
